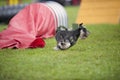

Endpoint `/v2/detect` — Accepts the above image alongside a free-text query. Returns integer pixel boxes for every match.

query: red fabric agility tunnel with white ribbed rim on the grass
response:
[0,1,67,49]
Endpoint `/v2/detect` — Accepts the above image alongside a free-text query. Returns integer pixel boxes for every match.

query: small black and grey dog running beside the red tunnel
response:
[54,23,89,50]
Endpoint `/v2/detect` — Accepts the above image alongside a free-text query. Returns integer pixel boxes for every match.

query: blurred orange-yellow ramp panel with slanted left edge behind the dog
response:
[76,0,120,24]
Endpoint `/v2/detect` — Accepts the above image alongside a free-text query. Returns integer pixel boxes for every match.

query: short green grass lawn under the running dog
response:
[0,7,120,80]
